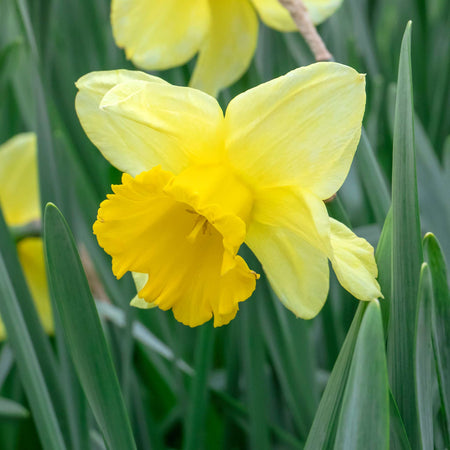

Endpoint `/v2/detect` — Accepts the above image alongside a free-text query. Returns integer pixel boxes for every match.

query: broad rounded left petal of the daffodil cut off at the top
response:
[111,0,209,70]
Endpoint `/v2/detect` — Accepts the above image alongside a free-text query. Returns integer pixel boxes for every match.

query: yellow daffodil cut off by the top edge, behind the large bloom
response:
[111,0,342,96]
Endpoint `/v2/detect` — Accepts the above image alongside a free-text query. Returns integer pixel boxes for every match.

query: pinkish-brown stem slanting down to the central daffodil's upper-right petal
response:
[278,0,333,61]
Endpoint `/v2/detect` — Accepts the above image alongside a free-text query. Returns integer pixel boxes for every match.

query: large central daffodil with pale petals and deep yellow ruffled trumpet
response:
[76,63,381,326]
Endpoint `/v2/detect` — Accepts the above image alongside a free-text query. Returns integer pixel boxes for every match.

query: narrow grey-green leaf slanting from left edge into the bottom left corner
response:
[0,253,66,450]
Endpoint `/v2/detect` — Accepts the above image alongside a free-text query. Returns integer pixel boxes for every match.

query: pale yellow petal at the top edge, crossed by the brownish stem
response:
[252,0,342,31]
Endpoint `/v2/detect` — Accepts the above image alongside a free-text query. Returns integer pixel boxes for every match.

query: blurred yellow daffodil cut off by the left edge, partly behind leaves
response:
[0,133,53,339]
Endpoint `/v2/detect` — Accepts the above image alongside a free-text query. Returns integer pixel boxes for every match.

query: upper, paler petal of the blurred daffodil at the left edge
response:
[0,133,41,225]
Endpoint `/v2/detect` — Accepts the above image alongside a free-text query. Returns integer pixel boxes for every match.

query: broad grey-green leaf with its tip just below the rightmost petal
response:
[335,301,389,450]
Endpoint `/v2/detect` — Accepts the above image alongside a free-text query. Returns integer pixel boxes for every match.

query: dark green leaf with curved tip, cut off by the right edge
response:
[424,233,450,446]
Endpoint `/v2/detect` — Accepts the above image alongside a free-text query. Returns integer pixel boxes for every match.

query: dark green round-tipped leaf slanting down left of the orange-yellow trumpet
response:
[44,204,136,450]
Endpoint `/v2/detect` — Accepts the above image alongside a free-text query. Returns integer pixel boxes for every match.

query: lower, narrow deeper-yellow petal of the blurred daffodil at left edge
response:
[17,238,53,333]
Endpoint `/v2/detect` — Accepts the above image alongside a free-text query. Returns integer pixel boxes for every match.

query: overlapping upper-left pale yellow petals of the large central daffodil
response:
[76,71,227,175]
